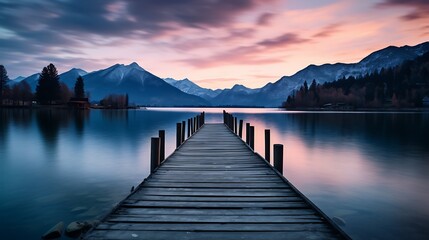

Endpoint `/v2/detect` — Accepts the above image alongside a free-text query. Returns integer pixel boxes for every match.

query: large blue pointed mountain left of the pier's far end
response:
[84,63,210,106]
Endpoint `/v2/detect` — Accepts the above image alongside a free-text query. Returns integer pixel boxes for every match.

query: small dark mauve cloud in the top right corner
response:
[376,0,429,21]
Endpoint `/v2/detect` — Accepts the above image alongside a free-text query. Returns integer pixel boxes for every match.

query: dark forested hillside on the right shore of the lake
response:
[283,52,429,108]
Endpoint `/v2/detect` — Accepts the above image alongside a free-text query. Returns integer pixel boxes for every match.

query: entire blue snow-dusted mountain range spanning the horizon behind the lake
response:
[13,42,429,107]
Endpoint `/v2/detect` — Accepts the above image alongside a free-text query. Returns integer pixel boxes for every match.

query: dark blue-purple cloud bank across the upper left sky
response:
[0,0,276,76]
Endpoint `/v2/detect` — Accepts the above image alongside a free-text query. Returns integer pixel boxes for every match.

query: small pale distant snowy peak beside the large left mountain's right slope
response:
[164,78,222,101]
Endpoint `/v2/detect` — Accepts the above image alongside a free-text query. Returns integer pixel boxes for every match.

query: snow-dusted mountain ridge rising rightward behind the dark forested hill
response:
[213,42,429,107]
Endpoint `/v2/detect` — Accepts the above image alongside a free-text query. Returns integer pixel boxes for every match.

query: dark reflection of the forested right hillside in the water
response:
[251,113,429,156]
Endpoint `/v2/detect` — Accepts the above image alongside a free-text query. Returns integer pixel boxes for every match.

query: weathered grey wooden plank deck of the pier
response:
[85,117,349,240]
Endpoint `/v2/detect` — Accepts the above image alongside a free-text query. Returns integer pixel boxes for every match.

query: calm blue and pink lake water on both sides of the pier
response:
[0,109,429,239]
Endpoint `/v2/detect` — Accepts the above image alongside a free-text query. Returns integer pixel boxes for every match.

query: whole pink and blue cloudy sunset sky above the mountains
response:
[0,0,429,88]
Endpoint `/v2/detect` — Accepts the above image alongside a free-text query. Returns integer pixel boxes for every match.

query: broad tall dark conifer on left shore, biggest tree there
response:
[36,63,61,104]
